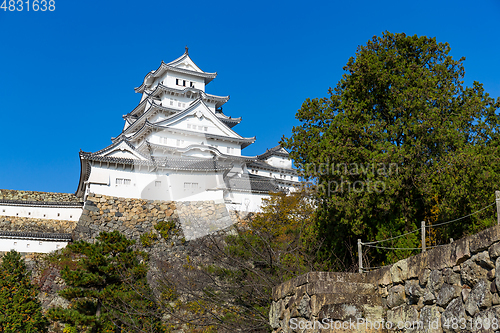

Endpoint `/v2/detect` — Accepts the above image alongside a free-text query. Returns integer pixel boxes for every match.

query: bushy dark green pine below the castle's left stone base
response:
[48,231,162,333]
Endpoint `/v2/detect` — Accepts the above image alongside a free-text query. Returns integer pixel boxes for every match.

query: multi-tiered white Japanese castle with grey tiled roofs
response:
[76,47,298,212]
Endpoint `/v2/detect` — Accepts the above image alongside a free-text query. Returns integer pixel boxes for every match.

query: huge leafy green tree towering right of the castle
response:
[282,32,500,269]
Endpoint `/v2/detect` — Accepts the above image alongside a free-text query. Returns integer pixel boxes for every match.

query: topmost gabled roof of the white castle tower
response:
[135,49,217,93]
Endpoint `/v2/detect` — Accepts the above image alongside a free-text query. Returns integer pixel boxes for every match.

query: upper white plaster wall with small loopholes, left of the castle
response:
[0,204,83,221]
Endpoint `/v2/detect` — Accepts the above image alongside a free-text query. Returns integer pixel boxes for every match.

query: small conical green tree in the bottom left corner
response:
[0,250,48,333]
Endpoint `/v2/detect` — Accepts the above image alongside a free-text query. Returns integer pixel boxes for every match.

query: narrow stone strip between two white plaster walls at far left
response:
[0,216,77,233]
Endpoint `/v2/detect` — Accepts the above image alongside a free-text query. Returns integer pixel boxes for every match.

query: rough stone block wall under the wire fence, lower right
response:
[269,226,500,332]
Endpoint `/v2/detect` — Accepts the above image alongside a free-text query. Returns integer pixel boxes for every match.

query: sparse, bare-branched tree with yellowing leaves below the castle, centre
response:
[154,188,329,332]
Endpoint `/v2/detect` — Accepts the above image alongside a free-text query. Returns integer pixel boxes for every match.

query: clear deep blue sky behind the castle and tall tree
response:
[0,0,500,192]
